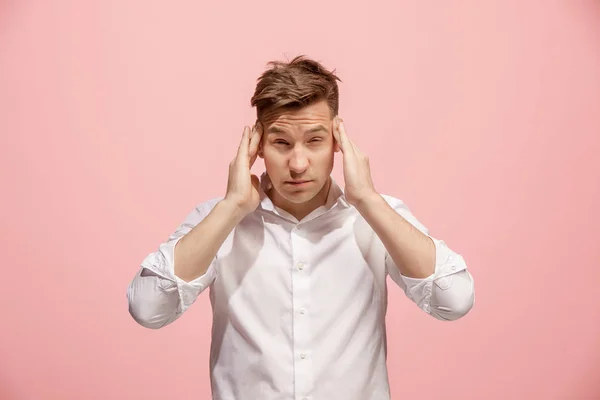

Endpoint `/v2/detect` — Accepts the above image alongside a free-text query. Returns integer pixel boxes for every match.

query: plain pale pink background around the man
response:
[0,0,600,400]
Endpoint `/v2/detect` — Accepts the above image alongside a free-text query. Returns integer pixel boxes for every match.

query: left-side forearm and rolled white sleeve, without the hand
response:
[127,199,237,329]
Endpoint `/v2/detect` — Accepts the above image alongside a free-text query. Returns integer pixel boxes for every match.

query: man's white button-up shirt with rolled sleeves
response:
[127,174,474,400]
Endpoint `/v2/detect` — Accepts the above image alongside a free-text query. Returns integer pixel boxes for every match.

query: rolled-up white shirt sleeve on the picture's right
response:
[382,196,475,321]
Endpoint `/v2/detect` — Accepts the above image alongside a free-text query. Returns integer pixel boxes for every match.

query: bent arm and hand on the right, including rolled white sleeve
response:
[333,116,475,320]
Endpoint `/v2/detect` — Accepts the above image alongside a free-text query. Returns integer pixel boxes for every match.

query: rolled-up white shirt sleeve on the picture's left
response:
[127,198,221,329]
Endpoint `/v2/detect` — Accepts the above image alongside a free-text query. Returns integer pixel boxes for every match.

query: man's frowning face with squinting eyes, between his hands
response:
[259,100,339,214]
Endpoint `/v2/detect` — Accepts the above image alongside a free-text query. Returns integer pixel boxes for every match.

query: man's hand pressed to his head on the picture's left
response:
[224,122,263,216]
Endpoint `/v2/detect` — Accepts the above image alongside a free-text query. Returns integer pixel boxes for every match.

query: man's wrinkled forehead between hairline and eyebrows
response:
[262,101,332,129]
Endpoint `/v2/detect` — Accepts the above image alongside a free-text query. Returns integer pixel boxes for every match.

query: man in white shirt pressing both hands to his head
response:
[127,57,474,400]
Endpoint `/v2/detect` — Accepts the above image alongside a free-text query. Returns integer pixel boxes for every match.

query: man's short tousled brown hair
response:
[250,55,342,120]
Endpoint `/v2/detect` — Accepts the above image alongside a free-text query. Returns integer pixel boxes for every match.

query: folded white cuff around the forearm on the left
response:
[141,236,217,314]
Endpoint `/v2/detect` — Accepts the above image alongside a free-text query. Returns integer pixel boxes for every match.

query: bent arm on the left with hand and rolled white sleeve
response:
[127,127,262,329]
